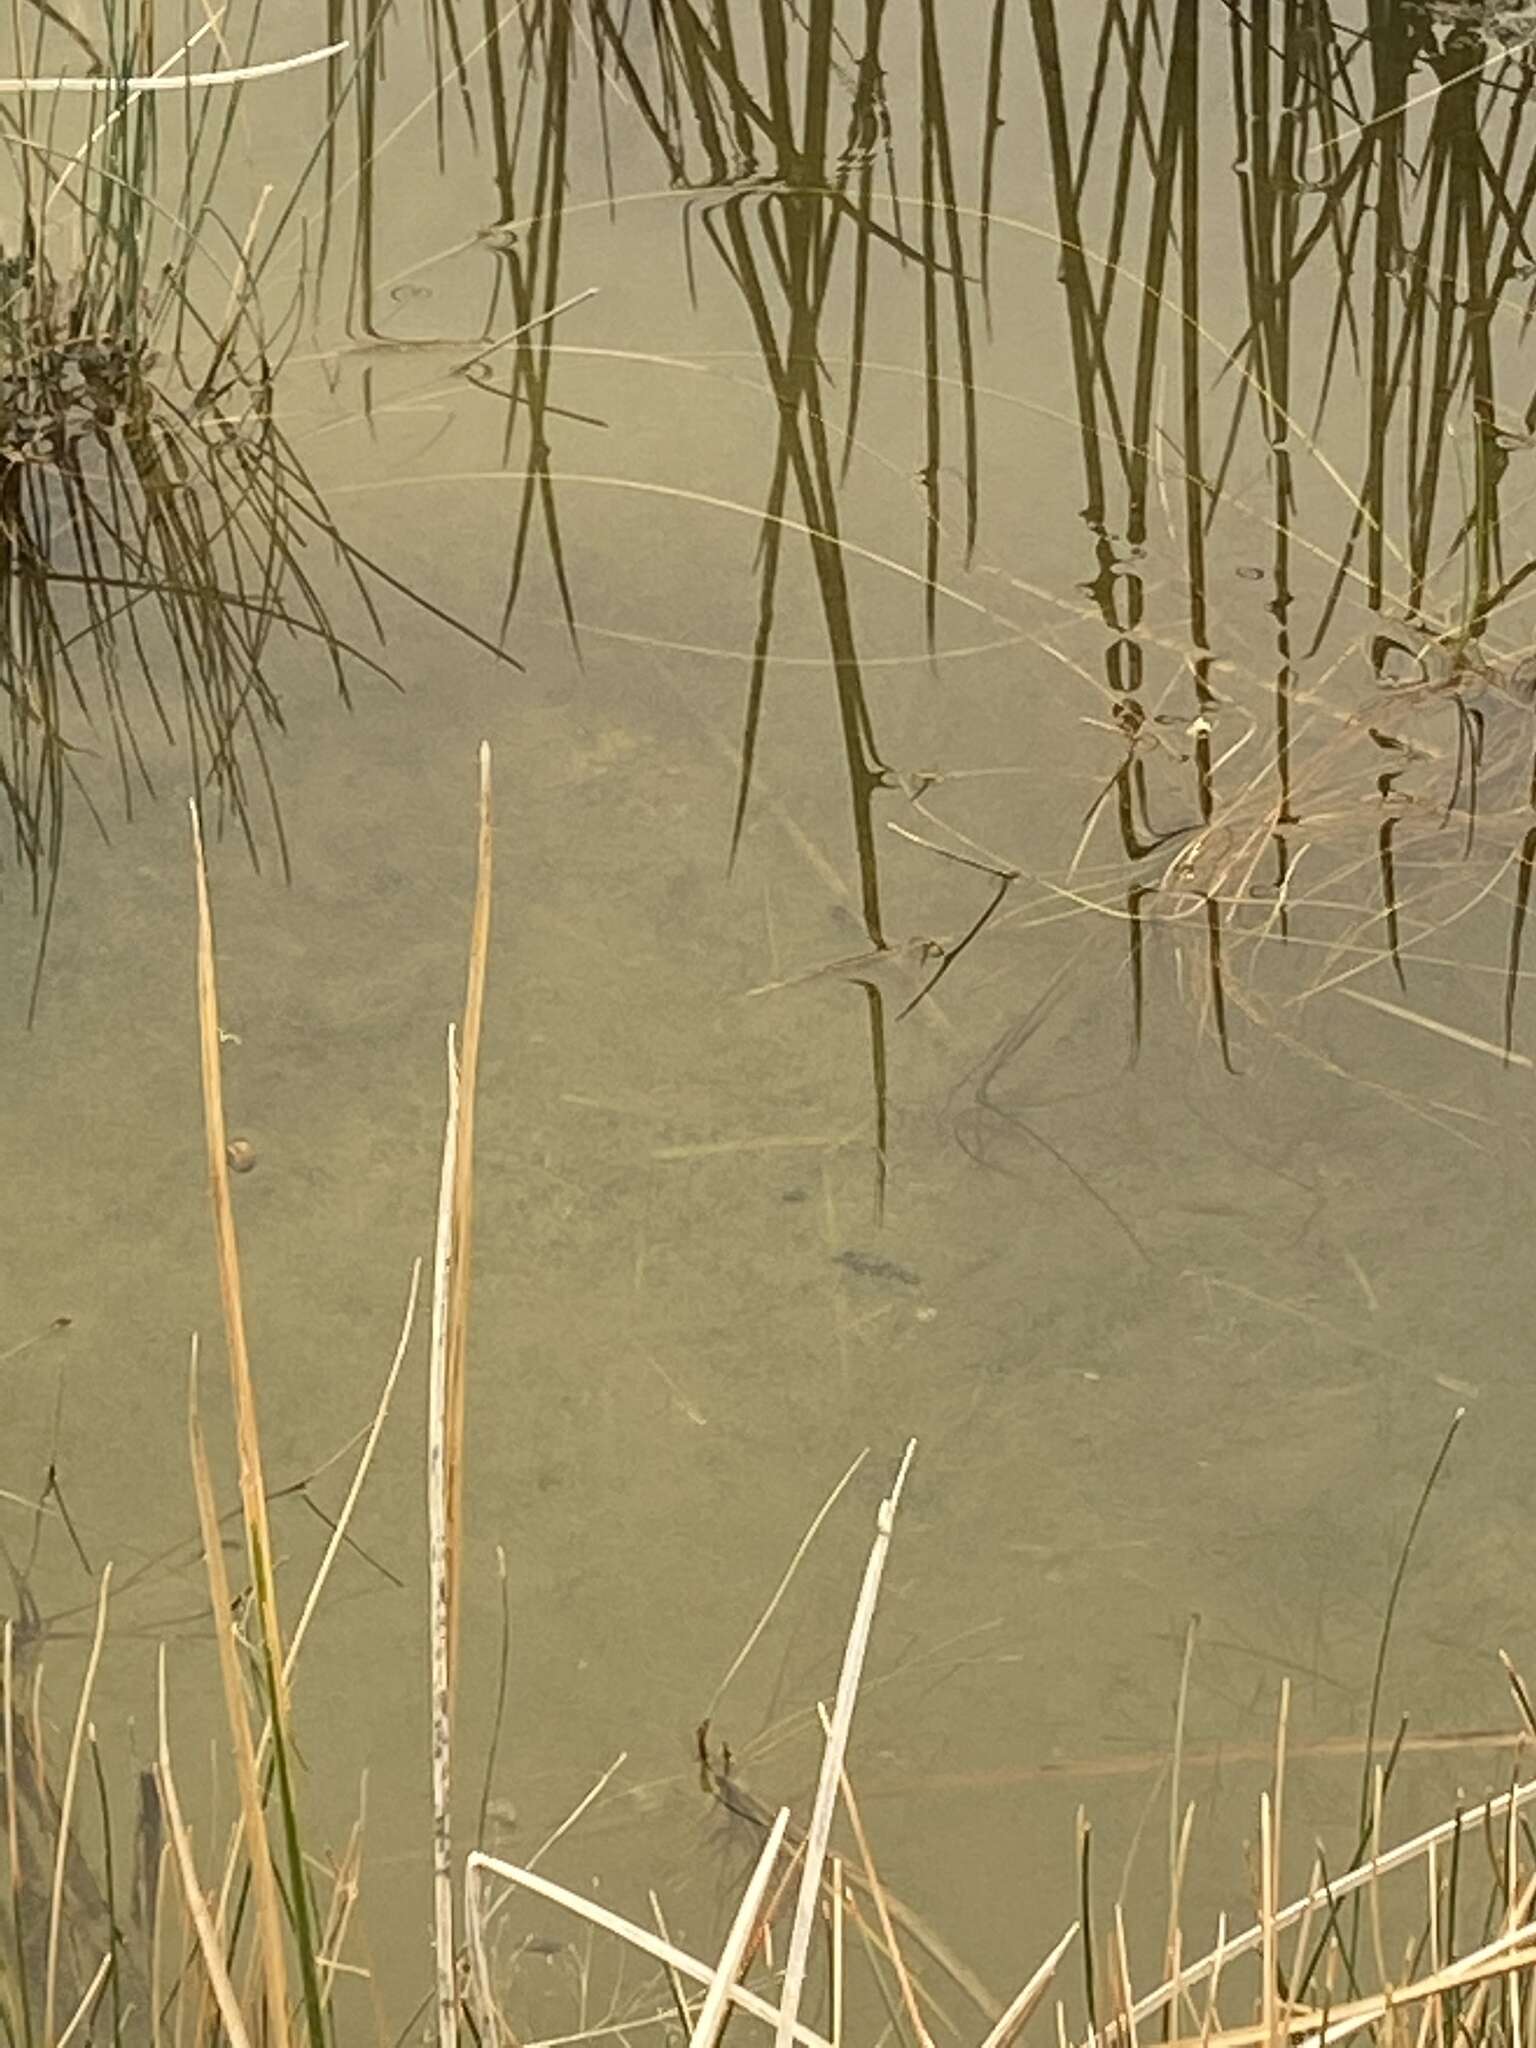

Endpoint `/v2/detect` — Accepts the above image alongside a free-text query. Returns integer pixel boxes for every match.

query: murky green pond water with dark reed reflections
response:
[0,0,1536,2036]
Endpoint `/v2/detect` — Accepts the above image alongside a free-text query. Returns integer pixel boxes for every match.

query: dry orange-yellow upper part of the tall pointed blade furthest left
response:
[188,803,289,1737]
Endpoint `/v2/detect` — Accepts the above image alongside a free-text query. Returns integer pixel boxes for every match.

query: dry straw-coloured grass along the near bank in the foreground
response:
[0,752,1536,2048]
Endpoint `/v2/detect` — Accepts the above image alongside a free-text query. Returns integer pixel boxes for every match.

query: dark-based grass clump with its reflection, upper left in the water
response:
[0,8,518,1003]
